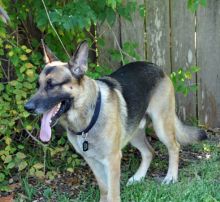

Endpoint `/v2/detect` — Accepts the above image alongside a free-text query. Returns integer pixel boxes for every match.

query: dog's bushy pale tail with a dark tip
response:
[175,116,208,145]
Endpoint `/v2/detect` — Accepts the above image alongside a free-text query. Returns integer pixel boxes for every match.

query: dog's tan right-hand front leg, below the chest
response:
[105,151,122,202]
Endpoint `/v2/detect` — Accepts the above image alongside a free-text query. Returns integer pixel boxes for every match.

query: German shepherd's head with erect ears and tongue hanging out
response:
[25,41,88,142]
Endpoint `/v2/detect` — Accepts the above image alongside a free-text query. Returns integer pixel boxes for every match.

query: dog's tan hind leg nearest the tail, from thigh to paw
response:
[147,77,180,184]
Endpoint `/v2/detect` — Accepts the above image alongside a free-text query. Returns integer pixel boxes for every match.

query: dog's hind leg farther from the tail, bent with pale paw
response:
[127,124,154,185]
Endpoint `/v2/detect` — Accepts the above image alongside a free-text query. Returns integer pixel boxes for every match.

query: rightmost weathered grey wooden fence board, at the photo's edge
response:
[197,0,220,127]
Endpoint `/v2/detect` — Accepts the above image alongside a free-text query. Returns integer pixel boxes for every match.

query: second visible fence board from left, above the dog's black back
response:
[121,0,145,61]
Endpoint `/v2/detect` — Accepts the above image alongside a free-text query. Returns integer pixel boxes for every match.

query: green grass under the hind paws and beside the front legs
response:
[75,148,220,202]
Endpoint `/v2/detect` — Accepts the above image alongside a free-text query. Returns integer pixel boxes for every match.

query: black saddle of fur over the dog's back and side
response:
[100,62,165,126]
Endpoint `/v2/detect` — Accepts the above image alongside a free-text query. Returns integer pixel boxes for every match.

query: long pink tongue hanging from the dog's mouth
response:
[40,106,57,142]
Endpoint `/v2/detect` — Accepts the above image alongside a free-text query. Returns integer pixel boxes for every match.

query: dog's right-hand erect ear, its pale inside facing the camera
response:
[69,41,89,77]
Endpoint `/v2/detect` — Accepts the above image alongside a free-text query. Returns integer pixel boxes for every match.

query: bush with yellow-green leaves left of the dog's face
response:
[0,22,42,189]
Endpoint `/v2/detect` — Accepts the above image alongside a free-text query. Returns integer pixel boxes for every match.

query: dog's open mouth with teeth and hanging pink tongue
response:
[40,99,72,142]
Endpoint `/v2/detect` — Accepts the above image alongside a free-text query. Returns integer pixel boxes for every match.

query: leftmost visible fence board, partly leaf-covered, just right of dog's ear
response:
[97,18,121,70]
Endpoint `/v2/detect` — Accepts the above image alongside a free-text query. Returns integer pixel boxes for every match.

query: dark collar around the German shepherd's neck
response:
[69,90,102,135]
